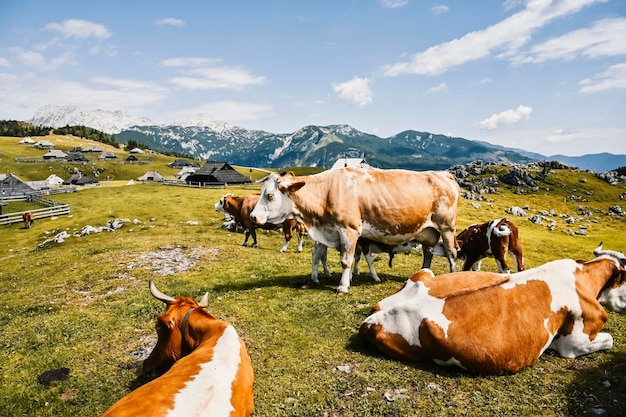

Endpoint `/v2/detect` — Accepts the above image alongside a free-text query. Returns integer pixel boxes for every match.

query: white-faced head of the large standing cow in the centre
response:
[250,172,304,225]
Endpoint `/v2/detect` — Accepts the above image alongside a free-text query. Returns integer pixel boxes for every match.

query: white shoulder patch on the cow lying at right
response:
[501,259,582,316]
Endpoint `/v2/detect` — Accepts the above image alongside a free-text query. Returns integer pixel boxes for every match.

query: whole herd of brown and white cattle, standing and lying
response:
[104,168,626,416]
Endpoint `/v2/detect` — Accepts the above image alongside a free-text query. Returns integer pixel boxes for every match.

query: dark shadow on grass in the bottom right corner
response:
[568,352,626,417]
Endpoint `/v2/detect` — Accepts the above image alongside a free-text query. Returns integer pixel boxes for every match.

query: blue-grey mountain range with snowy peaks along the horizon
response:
[27,105,626,172]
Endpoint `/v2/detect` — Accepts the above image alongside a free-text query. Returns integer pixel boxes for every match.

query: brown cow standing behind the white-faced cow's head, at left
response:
[215,194,306,252]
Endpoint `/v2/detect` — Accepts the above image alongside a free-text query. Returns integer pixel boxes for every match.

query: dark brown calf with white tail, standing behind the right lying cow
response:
[432,219,524,274]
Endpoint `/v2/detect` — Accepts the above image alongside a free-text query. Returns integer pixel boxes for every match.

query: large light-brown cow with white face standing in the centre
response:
[250,167,460,293]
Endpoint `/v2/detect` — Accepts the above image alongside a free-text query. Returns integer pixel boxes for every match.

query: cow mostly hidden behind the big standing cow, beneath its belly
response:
[313,237,421,282]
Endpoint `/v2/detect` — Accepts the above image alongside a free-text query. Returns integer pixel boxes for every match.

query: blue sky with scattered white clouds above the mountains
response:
[0,0,626,156]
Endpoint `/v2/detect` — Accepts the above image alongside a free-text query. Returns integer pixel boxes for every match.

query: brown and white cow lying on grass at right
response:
[360,240,626,374]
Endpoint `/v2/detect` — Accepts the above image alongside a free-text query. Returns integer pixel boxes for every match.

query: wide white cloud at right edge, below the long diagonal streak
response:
[512,18,626,64]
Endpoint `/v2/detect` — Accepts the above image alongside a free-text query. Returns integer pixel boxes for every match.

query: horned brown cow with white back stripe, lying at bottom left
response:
[103,280,254,417]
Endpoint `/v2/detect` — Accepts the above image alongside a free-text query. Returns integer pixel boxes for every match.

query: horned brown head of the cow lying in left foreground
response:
[143,280,209,375]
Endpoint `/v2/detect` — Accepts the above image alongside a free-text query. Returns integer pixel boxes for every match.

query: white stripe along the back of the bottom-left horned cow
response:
[167,326,241,417]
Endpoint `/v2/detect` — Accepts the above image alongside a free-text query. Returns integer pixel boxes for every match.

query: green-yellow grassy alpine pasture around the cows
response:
[0,137,626,417]
